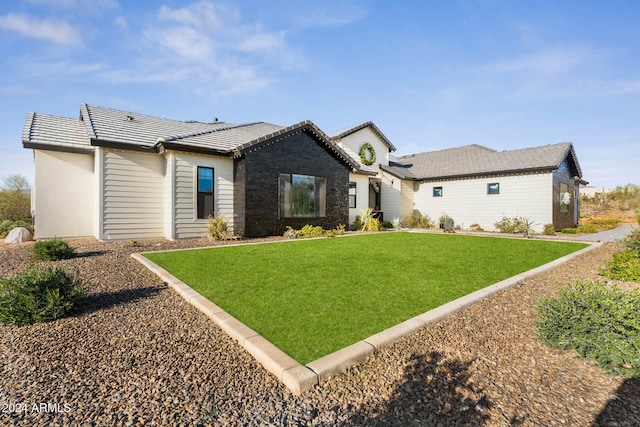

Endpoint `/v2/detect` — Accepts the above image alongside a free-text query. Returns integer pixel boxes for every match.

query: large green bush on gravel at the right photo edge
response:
[536,281,640,376]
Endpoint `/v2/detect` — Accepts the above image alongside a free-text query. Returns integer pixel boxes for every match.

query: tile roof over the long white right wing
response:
[384,142,582,180]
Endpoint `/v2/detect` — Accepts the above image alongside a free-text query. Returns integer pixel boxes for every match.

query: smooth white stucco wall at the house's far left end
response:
[32,150,94,239]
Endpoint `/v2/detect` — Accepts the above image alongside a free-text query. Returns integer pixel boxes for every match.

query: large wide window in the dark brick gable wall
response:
[279,173,327,218]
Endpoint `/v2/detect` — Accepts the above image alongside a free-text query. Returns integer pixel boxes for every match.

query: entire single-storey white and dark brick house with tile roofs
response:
[22,104,584,240]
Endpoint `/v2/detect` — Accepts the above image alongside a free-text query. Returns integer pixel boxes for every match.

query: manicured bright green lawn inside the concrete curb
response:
[145,232,586,364]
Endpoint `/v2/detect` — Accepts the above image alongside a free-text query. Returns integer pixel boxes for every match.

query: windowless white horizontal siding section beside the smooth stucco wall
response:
[101,151,165,240]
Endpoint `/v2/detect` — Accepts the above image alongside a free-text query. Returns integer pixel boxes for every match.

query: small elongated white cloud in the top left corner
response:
[0,13,82,46]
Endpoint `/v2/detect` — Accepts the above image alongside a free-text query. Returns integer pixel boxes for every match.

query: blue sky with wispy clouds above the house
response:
[0,0,640,188]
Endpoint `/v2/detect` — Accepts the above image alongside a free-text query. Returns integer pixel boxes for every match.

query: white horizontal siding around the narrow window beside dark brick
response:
[174,153,233,239]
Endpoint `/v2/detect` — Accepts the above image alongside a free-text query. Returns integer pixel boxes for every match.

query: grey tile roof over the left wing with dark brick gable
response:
[22,104,360,170]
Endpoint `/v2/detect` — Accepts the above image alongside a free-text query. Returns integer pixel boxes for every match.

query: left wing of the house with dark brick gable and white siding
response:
[22,104,359,240]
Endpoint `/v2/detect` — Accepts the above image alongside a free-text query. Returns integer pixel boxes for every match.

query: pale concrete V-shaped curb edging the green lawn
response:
[131,242,602,395]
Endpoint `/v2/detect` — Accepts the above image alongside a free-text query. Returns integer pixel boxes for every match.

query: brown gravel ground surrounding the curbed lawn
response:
[0,239,640,426]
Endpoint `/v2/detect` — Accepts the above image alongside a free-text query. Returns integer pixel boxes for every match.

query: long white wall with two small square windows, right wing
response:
[415,173,553,232]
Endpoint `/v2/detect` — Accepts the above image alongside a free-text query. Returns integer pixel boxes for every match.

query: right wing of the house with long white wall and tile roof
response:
[381,142,586,231]
